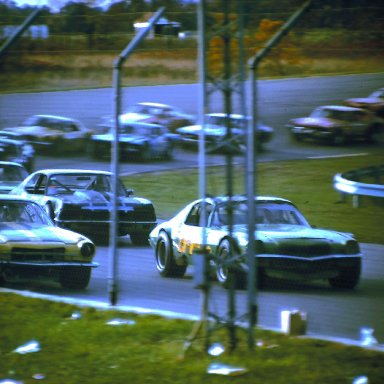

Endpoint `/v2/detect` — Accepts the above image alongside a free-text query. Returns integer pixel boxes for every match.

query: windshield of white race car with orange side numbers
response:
[217,202,309,226]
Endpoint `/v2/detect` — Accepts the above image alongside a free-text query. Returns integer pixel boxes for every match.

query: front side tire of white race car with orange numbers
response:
[216,239,247,289]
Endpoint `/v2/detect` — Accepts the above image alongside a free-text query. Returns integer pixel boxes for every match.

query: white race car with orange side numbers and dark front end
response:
[149,196,362,289]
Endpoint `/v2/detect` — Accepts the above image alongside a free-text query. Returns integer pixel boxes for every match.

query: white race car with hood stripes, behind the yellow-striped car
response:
[11,169,156,244]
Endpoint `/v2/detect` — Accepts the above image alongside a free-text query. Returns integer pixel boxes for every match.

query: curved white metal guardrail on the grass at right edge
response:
[333,164,384,208]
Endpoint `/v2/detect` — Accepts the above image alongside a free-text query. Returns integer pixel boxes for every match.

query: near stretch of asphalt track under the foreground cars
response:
[3,241,384,344]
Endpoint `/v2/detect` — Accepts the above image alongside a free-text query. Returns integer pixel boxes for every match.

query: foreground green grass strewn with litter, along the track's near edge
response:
[0,293,384,384]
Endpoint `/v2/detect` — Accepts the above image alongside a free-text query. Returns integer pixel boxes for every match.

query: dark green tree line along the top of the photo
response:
[0,0,384,35]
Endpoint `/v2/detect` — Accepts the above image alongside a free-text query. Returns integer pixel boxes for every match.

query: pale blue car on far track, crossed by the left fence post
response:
[89,122,175,161]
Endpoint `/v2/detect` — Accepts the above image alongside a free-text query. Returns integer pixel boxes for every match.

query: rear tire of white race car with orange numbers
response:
[155,232,187,277]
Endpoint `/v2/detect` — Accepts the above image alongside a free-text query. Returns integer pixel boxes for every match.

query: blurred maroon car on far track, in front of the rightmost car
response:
[287,105,384,145]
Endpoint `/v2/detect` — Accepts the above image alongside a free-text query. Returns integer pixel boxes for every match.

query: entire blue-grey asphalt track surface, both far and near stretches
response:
[0,74,384,343]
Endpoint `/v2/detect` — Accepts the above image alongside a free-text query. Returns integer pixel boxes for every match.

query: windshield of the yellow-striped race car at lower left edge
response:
[0,201,53,225]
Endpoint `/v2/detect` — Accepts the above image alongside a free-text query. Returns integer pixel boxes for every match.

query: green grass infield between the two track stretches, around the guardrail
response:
[124,155,384,244]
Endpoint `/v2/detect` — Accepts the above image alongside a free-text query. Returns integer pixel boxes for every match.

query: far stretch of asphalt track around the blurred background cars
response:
[0,73,384,173]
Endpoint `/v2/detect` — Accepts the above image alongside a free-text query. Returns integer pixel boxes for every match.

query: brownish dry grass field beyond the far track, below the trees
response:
[0,51,383,92]
